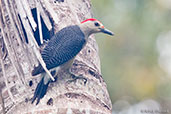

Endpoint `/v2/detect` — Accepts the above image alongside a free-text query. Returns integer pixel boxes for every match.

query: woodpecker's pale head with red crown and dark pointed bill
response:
[80,18,114,36]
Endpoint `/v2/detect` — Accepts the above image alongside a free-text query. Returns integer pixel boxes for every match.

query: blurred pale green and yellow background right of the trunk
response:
[91,0,171,114]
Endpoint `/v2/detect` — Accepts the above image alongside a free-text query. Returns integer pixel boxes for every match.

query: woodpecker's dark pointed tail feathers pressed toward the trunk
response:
[32,77,50,105]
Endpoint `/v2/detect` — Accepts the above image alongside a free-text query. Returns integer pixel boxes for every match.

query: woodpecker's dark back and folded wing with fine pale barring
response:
[32,25,86,76]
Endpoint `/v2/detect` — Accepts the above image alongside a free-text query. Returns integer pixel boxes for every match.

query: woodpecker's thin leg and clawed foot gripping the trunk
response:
[67,70,87,85]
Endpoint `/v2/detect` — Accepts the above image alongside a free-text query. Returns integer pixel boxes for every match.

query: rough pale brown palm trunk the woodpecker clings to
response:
[0,0,112,114]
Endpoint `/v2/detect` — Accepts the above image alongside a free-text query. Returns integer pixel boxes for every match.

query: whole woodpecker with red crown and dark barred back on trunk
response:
[32,18,114,105]
